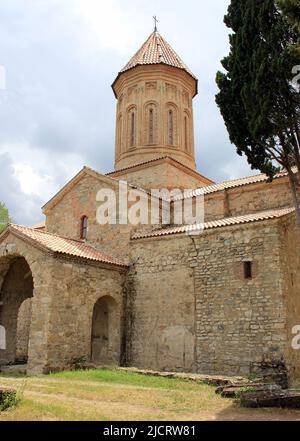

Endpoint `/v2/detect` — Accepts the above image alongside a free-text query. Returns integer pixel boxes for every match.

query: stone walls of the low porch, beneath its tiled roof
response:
[0,234,125,374]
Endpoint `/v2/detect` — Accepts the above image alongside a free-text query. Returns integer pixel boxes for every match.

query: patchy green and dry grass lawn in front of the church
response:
[0,369,300,421]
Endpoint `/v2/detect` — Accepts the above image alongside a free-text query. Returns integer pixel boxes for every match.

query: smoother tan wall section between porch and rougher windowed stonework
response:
[126,236,195,371]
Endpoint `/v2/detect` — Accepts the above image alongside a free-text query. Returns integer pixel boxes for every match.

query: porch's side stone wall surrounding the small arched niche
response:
[47,260,125,371]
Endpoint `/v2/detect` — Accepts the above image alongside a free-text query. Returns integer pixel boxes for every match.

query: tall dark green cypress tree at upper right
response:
[216,0,300,228]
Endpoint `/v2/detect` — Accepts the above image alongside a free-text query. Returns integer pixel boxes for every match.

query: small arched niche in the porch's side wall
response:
[91,296,120,365]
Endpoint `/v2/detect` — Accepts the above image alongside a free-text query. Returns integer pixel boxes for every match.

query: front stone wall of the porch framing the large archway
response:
[0,234,61,373]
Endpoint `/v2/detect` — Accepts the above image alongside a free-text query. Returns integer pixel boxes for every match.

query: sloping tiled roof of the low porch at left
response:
[0,225,127,268]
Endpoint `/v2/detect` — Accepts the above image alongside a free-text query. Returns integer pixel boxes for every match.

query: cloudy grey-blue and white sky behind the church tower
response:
[0,0,251,225]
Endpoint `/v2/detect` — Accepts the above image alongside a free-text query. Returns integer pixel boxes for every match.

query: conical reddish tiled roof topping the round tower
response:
[120,31,196,79]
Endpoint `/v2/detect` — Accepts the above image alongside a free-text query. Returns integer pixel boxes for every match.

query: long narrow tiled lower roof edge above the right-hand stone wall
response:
[131,208,295,240]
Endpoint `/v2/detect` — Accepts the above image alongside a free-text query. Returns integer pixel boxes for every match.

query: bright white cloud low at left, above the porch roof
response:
[0,143,82,224]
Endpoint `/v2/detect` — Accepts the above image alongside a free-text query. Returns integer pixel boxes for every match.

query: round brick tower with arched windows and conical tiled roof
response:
[112,30,198,170]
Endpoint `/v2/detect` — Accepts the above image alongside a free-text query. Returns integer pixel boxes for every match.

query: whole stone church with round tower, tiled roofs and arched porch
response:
[0,30,300,383]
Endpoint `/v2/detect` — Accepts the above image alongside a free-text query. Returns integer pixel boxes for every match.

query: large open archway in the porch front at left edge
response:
[0,256,33,365]
